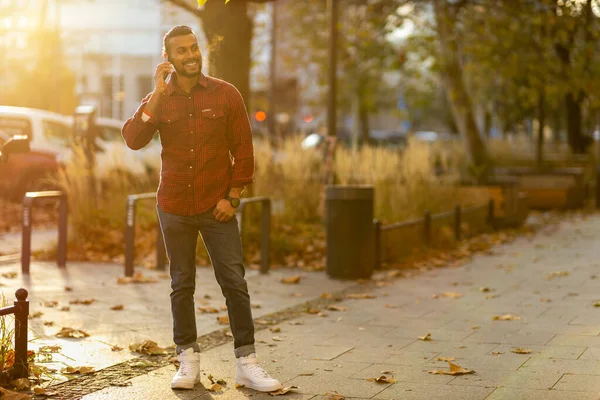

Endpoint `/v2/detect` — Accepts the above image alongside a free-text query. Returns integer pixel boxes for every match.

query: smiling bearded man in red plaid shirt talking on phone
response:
[122,26,282,392]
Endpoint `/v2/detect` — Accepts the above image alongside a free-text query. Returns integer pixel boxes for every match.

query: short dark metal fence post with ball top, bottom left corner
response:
[0,288,29,380]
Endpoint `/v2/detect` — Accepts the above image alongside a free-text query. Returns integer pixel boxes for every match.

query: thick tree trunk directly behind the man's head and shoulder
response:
[199,0,253,110]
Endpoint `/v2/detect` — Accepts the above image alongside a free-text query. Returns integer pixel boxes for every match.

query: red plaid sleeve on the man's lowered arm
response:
[227,86,254,188]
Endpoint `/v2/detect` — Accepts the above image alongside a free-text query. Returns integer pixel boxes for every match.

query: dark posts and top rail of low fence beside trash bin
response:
[373,199,494,269]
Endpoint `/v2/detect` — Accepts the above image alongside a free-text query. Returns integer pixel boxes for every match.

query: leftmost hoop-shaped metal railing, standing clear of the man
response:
[21,190,69,275]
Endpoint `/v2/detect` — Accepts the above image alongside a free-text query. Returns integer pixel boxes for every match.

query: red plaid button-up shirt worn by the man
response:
[122,73,254,215]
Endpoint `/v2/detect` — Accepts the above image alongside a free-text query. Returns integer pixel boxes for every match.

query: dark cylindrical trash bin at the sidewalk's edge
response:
[325,185,375,279]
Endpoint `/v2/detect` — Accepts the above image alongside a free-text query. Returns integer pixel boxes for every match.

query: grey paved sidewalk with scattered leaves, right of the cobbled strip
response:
[72,216,600,400]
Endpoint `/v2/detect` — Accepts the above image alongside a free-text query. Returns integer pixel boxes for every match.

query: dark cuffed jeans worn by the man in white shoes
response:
[157,207,255,357]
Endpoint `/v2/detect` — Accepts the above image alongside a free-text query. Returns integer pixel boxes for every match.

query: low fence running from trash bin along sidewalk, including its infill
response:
[374,200,494,269]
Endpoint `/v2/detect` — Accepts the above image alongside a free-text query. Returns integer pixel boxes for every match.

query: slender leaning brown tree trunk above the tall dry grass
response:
[434,0,489,178]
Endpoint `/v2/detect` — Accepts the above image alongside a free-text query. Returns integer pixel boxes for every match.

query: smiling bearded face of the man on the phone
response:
[165,33,202,78]
